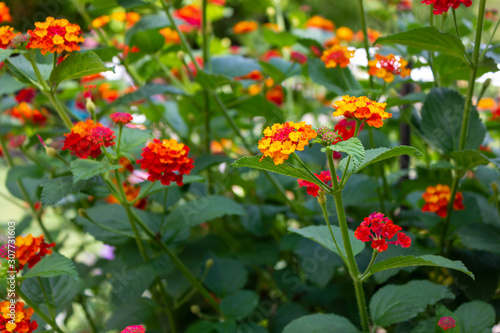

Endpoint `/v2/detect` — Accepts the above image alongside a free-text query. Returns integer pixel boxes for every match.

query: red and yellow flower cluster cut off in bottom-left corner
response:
[0,301,38,333]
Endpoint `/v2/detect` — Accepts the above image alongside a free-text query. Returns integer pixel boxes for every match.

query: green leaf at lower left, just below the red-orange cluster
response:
[23,252,78,279]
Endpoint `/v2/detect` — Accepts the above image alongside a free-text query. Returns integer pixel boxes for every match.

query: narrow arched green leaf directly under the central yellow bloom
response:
[231,156,320,185]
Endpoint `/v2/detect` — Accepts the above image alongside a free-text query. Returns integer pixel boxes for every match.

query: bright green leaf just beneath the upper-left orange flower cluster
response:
[50,51,114,83]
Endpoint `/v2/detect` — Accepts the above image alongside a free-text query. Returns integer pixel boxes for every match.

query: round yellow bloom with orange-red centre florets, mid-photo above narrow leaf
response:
[259,121,317,165]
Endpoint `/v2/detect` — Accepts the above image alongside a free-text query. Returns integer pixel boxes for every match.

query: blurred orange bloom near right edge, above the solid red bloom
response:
[422,184,465,217]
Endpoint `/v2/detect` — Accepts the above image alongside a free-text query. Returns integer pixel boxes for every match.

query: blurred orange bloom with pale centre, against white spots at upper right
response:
[368,54,411,83]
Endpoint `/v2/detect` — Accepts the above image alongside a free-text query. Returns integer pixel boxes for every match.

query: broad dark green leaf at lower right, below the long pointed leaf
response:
[370,280,455,326]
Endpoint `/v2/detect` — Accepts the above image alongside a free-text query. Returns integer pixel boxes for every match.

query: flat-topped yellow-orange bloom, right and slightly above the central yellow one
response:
[333,96,392,127]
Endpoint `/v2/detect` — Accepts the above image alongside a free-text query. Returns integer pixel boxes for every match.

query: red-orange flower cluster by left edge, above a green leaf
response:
[16,234,55,270]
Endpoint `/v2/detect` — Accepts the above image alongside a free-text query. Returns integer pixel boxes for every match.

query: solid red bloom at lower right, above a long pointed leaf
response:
[354,212,411,252]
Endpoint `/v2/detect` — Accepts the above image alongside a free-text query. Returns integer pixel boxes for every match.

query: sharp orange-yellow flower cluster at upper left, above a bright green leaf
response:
[27,17,85,55]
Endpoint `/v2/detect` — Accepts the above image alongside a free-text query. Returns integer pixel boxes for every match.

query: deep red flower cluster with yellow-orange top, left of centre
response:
[137,139,194,186]
